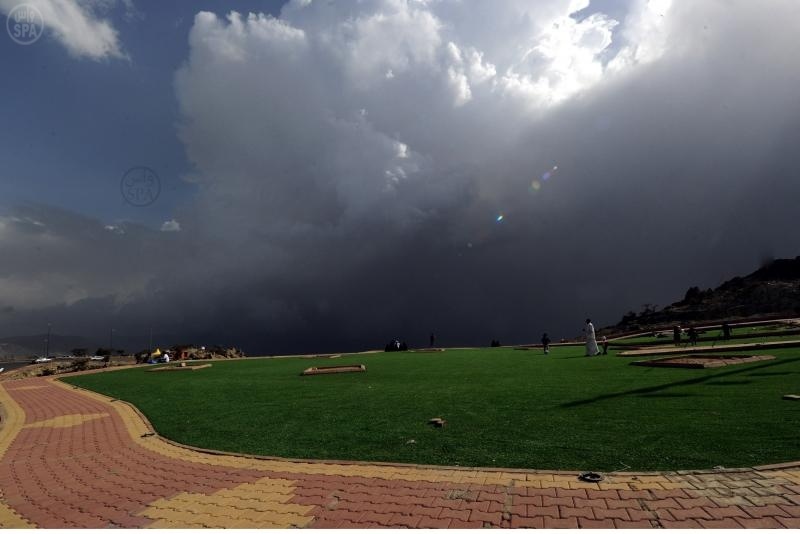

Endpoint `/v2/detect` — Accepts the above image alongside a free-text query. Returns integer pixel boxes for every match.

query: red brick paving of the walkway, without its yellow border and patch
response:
[0,379,800,528]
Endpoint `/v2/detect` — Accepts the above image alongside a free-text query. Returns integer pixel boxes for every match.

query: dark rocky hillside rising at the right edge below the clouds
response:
[603,256,800,333]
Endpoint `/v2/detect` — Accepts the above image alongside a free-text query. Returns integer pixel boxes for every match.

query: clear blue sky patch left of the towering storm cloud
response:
[0,0,283,225]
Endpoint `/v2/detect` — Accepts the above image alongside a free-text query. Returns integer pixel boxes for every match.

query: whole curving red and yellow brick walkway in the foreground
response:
[0,378,800,528]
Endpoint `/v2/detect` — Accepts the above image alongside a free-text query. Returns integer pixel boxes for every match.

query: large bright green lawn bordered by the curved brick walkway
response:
[63,347,800,471]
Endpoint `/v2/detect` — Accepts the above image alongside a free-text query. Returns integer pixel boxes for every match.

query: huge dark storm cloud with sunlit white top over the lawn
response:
[0,1,800,353]
